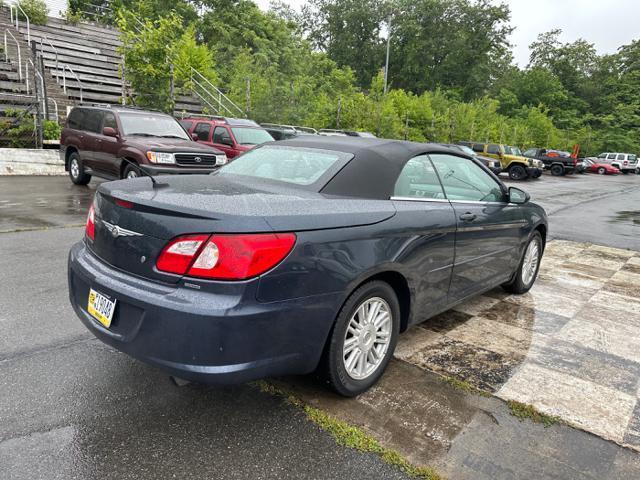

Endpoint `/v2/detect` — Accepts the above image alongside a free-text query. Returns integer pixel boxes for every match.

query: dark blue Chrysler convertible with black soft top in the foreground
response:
[69,136,547,396]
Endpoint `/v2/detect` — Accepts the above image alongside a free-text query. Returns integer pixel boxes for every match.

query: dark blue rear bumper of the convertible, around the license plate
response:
[68,242,340,383]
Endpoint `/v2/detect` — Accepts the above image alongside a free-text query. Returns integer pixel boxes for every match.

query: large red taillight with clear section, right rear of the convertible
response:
[156,233,296,280]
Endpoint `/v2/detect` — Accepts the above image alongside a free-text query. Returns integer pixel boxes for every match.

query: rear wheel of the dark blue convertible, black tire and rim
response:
[320,281,400,397]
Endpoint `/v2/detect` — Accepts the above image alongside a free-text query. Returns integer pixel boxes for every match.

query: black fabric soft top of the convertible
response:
[278,135,470,200]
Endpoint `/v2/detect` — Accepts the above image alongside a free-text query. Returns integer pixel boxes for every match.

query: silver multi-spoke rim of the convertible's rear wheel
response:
[342,297,392,380]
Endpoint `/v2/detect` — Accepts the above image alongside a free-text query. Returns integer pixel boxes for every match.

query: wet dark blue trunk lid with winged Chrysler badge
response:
[89,175,395,283]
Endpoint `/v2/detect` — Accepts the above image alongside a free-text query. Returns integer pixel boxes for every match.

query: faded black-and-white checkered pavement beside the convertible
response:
[396,240,640,451]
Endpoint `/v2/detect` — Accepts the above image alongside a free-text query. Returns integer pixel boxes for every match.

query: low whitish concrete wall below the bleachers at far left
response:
[0,148,65,175]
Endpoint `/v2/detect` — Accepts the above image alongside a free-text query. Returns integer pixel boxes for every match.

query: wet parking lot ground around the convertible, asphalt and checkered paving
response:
[0,175,640,480]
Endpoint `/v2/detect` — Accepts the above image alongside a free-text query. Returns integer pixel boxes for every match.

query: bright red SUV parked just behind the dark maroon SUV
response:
[180,117,274,160]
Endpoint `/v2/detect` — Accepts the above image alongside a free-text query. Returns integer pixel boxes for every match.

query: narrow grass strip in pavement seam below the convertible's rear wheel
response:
[255,380,443,480]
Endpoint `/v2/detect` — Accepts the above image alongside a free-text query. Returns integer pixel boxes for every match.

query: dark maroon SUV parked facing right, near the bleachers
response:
[60,106,227,185]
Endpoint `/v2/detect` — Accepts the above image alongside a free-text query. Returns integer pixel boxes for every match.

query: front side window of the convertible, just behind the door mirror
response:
[431,154,504,202]
